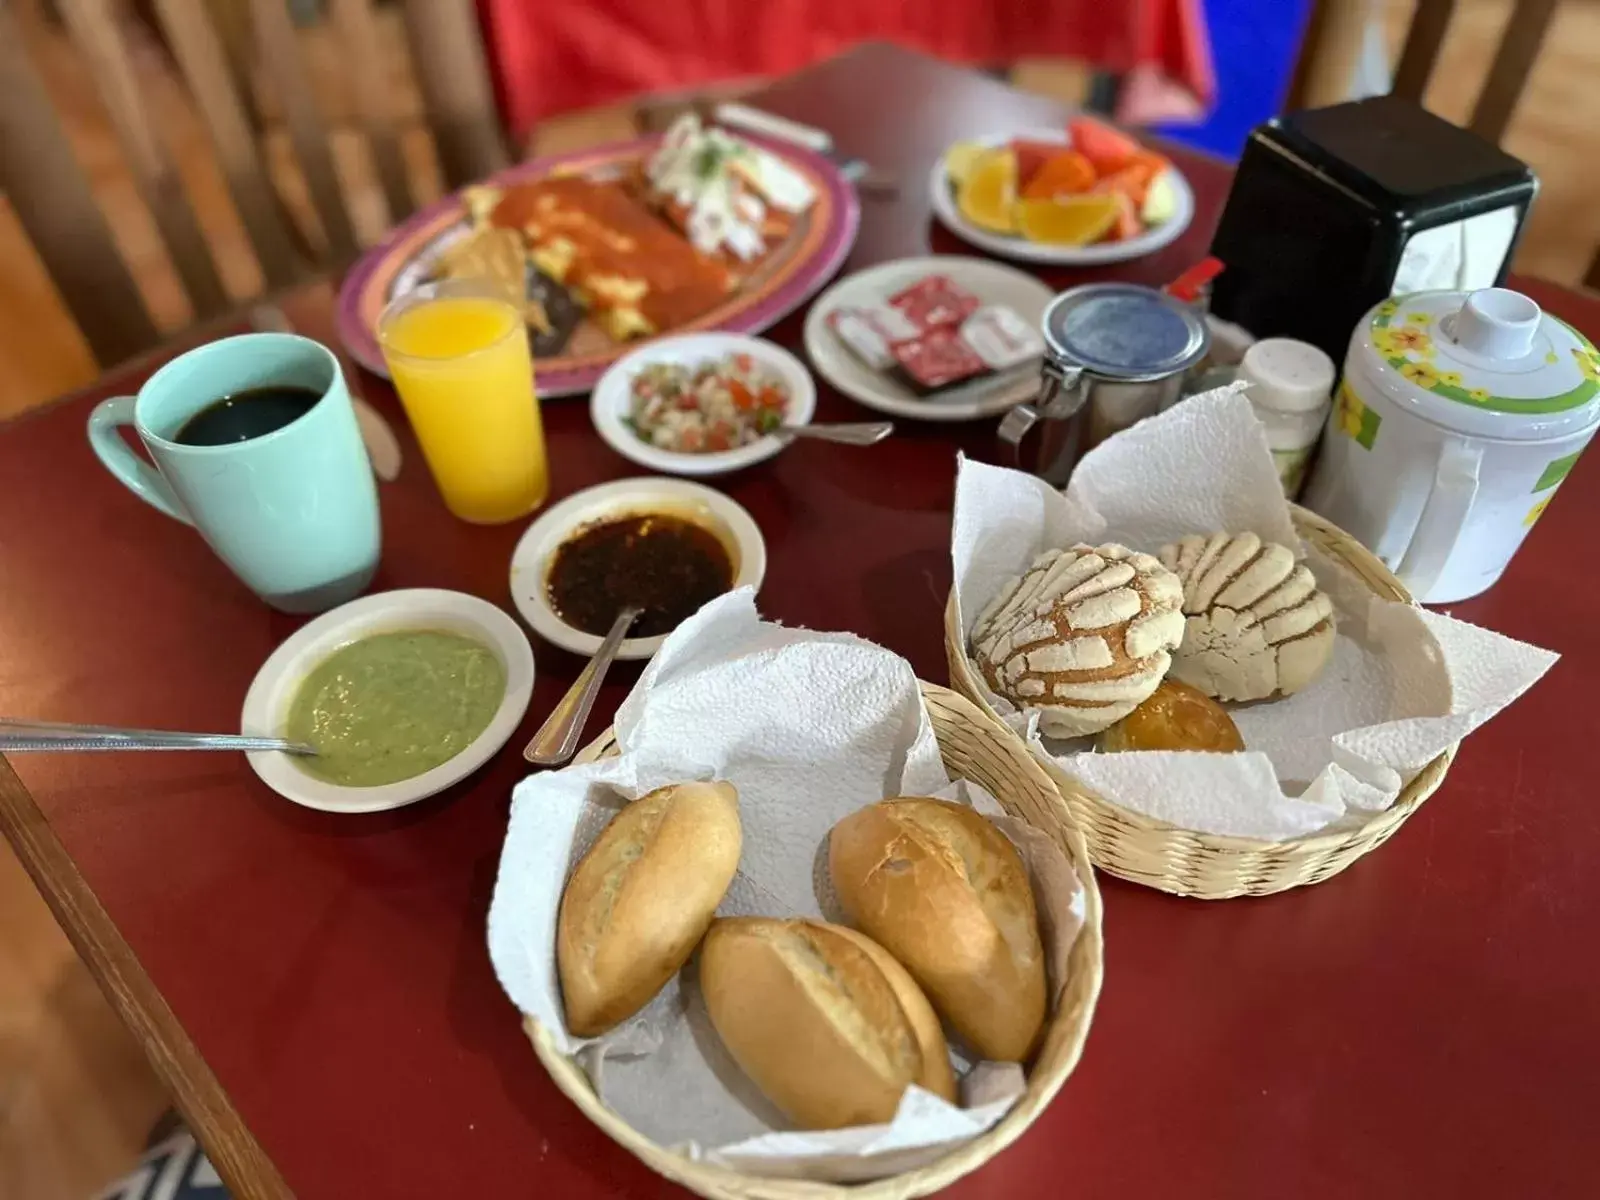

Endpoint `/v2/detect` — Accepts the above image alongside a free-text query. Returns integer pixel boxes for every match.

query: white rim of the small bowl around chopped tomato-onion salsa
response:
[589,333,816,475]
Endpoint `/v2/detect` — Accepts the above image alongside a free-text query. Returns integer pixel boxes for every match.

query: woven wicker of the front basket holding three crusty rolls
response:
[525,683,1104,1200]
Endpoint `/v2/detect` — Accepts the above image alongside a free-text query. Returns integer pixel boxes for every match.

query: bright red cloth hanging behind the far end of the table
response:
[478,0,1214,142]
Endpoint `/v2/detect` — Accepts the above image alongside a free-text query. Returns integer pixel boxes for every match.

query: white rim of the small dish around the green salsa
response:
[240,587,533,813]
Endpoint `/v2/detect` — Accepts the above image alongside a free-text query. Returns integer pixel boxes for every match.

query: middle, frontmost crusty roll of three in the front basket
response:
[699,917,955,1130]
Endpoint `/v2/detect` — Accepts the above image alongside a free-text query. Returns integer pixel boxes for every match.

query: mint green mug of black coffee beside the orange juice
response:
[88,333,379,613]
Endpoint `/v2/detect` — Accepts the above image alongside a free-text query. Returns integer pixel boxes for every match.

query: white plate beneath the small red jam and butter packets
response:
[805,254,1056,421]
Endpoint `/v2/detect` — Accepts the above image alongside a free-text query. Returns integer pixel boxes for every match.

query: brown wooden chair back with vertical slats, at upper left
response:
[0,0,506,366]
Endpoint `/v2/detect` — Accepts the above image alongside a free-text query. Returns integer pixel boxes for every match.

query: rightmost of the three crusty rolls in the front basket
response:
[827,797,1045,1062]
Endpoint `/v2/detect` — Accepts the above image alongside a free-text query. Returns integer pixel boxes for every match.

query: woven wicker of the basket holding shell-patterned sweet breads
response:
[944,506,1456,899]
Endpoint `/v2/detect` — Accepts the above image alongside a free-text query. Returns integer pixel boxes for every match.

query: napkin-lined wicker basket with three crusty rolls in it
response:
[490,601,1102,1200]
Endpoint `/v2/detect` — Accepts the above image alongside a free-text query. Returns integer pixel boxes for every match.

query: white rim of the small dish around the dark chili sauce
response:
[510,477,766,658]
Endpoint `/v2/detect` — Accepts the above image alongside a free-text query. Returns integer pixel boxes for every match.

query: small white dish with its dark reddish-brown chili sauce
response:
[510,477,766,659]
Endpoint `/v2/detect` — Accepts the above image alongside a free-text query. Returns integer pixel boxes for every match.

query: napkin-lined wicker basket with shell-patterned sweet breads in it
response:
[946,394,1554,899]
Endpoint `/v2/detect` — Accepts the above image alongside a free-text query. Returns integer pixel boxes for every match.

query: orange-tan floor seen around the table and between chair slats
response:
[0,0,1600,1200]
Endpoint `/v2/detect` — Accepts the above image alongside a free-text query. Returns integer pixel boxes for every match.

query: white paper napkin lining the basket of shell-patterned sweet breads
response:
[950,386,1557,840]
